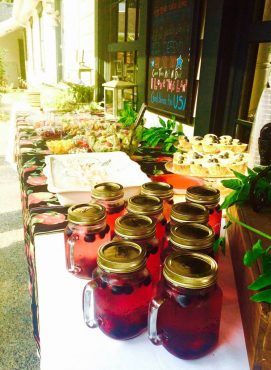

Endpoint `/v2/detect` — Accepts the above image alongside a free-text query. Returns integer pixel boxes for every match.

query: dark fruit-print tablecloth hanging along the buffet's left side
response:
[7,109,176,348]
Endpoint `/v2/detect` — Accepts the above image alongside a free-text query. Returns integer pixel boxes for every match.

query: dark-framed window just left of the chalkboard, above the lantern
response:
[105,0,147,104]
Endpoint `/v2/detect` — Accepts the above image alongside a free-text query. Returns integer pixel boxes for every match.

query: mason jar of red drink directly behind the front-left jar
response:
[114,213,161,286]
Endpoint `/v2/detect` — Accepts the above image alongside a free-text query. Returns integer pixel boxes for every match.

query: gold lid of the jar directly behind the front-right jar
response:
[169,222,215,250]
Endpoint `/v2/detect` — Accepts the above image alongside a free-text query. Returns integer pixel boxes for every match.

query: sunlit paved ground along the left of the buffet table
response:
[0,93,39,370]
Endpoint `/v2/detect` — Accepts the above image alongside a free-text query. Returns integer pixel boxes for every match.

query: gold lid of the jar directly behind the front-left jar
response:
[115,213,156,239]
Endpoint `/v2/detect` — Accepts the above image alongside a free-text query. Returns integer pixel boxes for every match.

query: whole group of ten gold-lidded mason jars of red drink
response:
[65,182,222,359]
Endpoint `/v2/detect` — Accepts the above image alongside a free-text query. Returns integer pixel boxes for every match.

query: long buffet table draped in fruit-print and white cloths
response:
[11,112,249,370]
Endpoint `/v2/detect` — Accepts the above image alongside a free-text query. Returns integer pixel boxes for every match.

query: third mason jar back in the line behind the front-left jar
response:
[127,195,167,250]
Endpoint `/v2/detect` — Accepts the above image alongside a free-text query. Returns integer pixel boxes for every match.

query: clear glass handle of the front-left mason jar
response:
[83,280,98,328]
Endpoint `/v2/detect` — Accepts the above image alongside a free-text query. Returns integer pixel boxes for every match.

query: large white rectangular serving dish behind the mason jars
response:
[44,152,151,206]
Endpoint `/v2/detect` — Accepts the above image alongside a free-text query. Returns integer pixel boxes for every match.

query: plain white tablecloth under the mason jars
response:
[35,233,249,370]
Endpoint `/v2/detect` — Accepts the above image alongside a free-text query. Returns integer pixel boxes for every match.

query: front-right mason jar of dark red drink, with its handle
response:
[148,253,222,360]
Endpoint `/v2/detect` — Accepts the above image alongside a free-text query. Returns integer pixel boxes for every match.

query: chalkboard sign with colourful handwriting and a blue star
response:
[147,0,199,123]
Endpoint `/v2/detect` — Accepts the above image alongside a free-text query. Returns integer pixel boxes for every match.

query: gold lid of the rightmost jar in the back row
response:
[185,185,220,205]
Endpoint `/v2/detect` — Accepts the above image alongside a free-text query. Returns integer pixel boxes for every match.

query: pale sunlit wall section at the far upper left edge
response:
[0,30,23,87]
